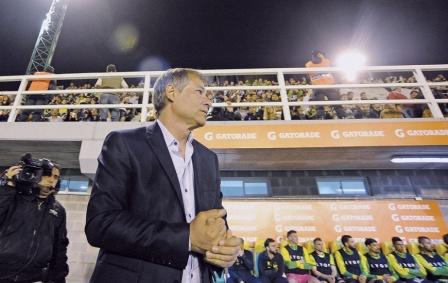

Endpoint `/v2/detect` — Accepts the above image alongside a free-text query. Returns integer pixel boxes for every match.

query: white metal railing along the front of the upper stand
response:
[0,65,448,122]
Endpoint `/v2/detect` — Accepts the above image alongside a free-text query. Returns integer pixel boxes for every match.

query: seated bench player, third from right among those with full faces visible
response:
[362,238,398,283]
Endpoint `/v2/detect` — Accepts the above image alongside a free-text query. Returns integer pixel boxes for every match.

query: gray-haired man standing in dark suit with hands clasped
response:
[85,69,241,283]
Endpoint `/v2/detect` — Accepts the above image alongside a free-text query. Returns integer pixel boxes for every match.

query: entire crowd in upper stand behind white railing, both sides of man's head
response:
[0,72,448,122]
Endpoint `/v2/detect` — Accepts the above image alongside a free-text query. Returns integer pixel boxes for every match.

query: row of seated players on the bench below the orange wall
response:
[227,233,448,283]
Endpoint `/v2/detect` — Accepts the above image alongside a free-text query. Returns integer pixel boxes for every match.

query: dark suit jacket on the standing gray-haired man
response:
[85,123,222,283]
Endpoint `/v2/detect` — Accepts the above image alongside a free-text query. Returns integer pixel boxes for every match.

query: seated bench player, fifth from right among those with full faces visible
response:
[311,238,344,283]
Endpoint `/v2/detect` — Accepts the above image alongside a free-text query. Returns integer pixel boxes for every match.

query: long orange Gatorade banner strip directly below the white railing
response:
[193,120,448,149]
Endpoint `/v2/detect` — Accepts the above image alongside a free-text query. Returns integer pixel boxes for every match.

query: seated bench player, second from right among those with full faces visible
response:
[387,237,429,283]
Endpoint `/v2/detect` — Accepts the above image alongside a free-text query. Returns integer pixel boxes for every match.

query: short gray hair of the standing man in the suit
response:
[153,68,206,115]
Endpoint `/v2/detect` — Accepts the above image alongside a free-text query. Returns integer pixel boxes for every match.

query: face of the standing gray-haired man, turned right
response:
[172,75,211,130]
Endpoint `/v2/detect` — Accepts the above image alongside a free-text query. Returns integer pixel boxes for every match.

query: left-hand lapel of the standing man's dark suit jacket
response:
[146,123,185,214]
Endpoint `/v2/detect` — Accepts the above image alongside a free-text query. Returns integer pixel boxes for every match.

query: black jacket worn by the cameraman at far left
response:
[0,186,68,282]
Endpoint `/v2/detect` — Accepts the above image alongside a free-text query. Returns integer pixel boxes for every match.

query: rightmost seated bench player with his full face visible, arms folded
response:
[415,236,448,281]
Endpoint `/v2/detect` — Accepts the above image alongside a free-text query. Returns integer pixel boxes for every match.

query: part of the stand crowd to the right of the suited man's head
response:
[209,75,448,121]
